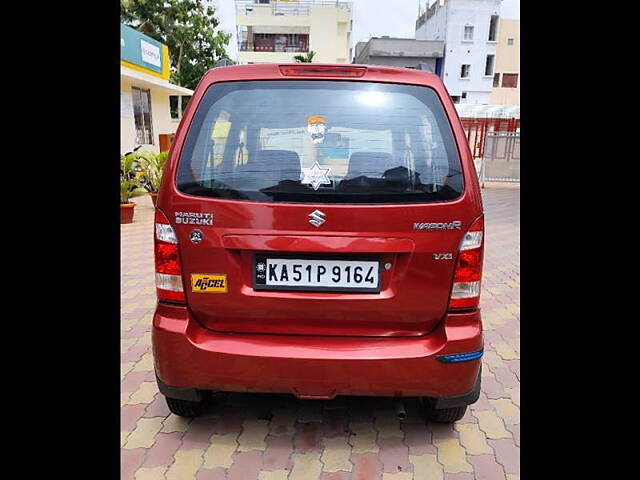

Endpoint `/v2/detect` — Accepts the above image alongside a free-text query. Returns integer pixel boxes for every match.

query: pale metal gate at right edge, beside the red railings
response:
[480,132,520,187]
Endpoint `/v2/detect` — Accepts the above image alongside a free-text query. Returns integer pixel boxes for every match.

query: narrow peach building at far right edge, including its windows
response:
[491,18,520,105]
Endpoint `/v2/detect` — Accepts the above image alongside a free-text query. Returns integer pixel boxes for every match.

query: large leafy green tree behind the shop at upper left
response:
[120,0,231,89]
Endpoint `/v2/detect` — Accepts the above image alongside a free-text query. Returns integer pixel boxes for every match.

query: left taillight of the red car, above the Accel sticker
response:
[154,209,185,303]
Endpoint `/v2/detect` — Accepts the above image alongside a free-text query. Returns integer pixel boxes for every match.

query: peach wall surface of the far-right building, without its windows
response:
[489,19,521,105]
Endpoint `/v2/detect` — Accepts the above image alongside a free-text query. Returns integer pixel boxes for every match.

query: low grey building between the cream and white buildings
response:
[354,37,444,71]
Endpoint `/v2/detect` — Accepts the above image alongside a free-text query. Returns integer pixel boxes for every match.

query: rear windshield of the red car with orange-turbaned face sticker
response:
[177,80,463,203]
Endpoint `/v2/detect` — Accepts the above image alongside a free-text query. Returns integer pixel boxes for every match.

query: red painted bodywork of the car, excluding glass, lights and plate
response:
[153,64,482,397]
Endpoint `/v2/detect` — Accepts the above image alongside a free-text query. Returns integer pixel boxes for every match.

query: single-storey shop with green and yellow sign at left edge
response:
[120,24,193,153]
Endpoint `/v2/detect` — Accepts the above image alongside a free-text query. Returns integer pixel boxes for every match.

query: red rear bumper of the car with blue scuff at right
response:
[152,304,483,402]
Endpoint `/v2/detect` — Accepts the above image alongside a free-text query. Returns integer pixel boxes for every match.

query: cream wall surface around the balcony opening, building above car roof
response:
[236,5,351,63]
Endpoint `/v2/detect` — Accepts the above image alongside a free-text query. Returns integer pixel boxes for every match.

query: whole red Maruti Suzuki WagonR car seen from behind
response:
[153,64,484,422]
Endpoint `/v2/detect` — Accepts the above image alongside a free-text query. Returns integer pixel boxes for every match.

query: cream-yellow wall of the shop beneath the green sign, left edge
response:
[120,77,178,153]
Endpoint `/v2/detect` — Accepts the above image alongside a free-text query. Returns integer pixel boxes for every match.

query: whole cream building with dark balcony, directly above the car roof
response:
[236,0,352,63]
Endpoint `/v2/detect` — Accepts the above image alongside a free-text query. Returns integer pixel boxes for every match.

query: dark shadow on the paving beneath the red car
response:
[185,393,457,442]
